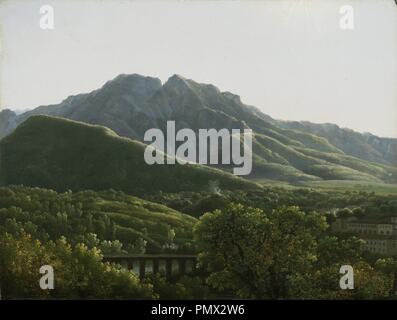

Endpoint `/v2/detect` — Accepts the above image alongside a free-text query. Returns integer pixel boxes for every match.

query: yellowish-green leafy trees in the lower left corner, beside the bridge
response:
[0,232,154,299]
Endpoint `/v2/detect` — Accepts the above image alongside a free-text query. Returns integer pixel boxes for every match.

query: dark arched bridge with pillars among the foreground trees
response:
[103,254,197,279]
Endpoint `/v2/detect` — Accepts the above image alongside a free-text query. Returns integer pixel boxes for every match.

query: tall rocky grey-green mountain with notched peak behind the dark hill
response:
[0,74,397,183]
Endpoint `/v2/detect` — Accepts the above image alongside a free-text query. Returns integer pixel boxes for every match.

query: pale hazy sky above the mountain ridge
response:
[0,0,397,137]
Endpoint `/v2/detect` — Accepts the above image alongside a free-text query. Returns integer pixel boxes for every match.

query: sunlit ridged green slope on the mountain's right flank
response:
[229,107,397,183]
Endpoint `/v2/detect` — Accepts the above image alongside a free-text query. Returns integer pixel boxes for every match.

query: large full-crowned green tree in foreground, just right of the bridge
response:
[195,204,326,299]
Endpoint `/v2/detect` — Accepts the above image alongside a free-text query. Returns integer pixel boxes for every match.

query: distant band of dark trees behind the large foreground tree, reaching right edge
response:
[147,186,397,221]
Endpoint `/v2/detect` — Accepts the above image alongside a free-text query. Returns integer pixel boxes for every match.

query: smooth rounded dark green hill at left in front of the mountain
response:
[0,116,257,195]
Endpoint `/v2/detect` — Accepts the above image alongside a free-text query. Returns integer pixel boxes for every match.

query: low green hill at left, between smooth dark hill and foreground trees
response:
[0,186,197,253]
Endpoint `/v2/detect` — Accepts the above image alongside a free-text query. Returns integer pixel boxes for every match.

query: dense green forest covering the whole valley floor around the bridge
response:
[0,184,397,299]
